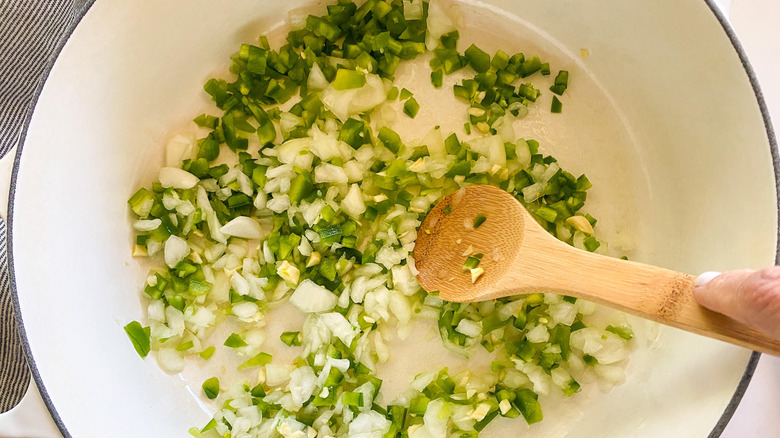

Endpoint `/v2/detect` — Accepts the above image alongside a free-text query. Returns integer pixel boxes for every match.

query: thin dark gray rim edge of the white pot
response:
[8,0,780,438]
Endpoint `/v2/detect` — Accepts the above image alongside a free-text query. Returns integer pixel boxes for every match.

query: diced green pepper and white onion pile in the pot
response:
[125,0,633,438]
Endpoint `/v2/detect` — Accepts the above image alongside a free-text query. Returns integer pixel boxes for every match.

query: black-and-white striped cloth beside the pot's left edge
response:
[0,0,88,413]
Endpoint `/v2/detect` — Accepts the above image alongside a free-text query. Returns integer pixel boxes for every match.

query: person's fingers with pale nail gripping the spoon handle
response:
[693,266,780,339]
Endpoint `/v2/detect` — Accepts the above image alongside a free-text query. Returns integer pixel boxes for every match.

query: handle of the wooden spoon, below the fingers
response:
[492,235,780,356]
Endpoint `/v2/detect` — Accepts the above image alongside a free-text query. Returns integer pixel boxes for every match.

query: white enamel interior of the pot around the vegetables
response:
[13,0,776,437]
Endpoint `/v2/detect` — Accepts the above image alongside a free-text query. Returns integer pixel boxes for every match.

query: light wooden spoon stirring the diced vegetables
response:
[414,185,780,355]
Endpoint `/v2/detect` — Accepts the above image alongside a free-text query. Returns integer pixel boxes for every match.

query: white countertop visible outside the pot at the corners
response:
[0,0,780,438]
